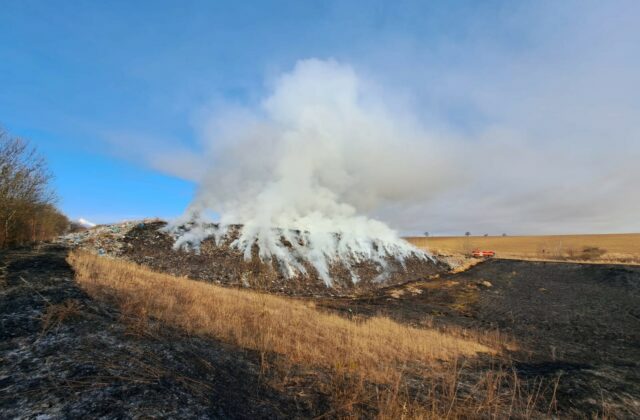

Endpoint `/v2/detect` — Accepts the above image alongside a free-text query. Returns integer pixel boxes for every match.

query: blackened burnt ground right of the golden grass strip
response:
[321,259,640,418]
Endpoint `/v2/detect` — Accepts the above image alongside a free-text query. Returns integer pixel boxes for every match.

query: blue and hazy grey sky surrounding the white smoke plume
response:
[0,0,640,235]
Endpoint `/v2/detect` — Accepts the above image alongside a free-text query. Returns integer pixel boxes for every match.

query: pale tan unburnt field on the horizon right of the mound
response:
[405,233,640,263]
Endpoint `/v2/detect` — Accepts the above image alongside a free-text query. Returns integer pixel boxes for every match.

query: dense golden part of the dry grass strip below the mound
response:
[70,253,494,382]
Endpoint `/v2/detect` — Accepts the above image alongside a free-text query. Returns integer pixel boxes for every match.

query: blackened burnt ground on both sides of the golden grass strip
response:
[0,245,640,418]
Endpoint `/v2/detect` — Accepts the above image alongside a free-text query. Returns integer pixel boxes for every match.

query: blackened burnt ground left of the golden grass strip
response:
[0,246,338,419]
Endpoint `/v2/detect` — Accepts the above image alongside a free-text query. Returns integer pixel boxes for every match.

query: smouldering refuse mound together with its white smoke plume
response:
[61,60,450,293]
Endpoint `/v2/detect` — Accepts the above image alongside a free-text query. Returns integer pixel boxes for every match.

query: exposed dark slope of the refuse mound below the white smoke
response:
[65,220,448,296]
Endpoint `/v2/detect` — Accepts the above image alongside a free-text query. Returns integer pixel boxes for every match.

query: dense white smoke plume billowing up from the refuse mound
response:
[168,60,455,285]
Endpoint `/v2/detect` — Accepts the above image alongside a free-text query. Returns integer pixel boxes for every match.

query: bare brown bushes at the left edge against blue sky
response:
[0,129,70,249]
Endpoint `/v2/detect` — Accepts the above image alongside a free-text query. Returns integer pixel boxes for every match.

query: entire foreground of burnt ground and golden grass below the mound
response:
[0,246,640,419]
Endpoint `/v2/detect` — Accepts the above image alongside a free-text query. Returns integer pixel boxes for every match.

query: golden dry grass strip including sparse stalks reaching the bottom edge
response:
[69,252,552,418]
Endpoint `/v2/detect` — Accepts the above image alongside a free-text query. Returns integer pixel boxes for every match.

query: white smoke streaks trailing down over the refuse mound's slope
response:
[164,223,435,286]
